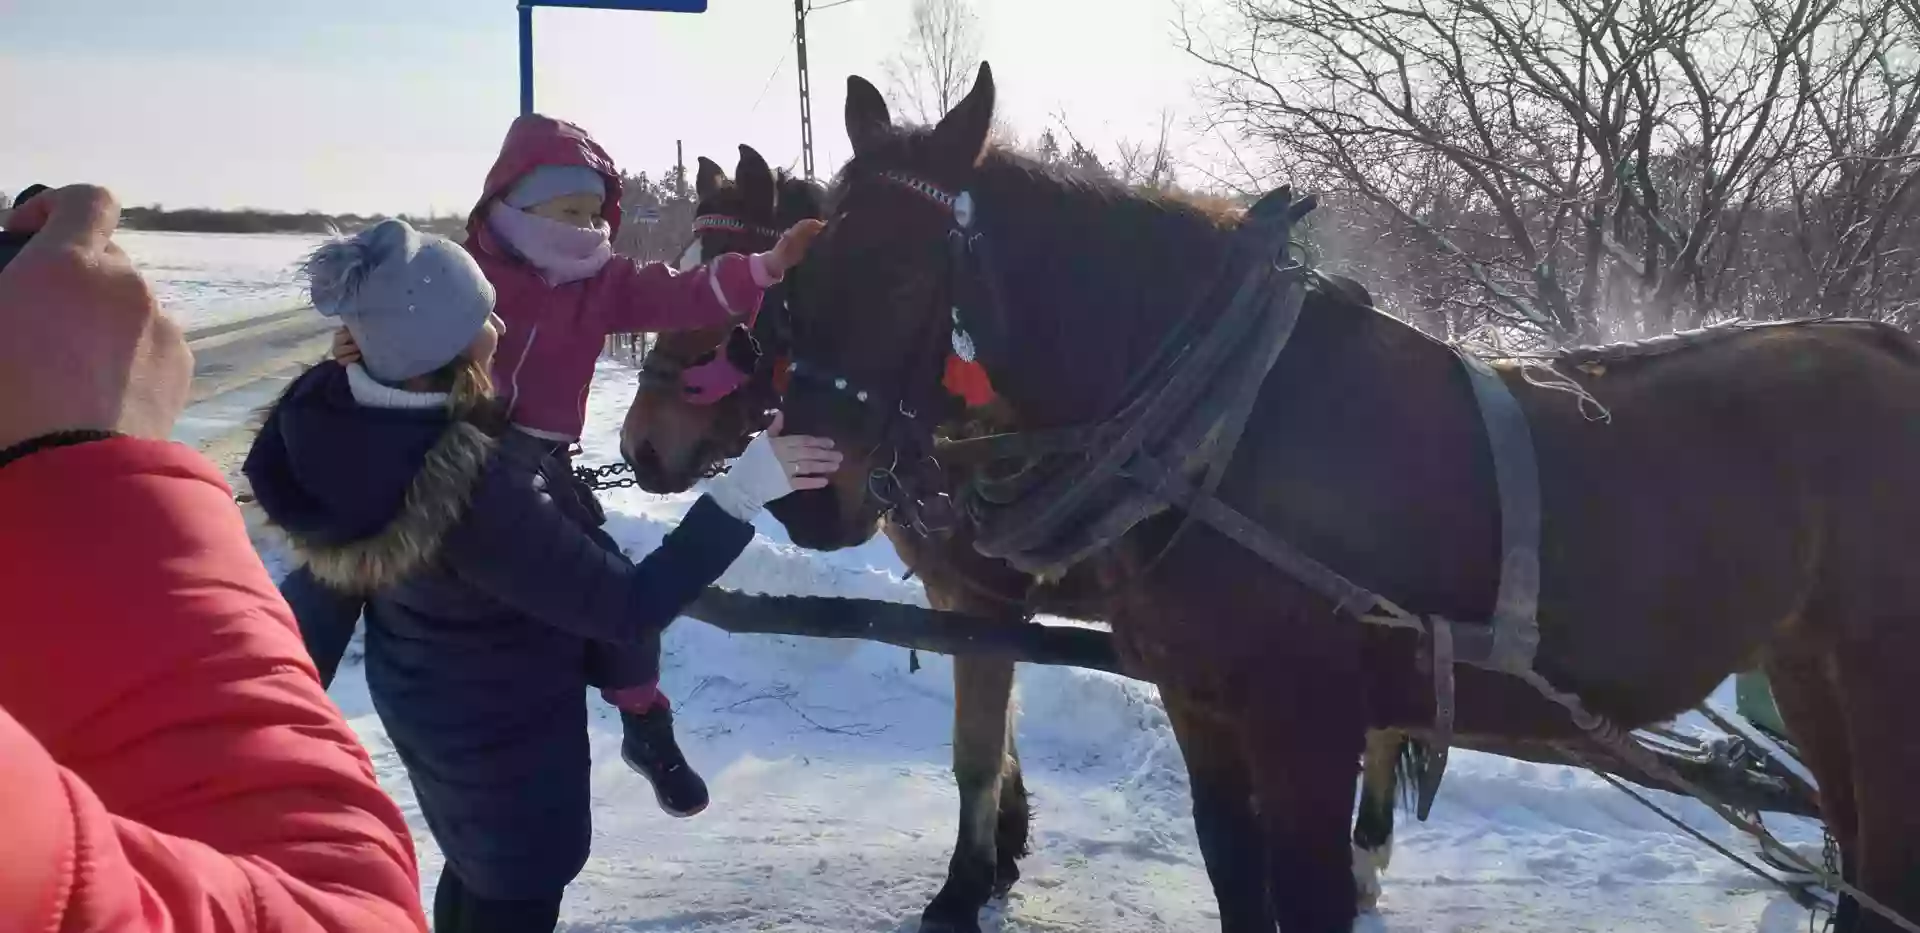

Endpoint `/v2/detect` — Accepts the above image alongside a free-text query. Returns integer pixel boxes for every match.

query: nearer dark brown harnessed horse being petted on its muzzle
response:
[756,67,1920,933]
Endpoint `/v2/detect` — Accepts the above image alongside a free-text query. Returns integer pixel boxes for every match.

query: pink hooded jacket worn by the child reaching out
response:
[467,113,776,440]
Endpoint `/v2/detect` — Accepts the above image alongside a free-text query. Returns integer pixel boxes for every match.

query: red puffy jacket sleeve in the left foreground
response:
[0,440,426,933]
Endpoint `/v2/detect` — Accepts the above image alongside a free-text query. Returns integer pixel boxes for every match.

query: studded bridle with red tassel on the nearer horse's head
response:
[787,171,1004,536]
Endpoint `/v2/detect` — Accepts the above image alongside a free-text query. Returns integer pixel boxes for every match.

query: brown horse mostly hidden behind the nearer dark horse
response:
[622,146,1428,933]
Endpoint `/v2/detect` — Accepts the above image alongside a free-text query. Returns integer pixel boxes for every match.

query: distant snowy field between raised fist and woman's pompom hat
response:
[113,230,324,330]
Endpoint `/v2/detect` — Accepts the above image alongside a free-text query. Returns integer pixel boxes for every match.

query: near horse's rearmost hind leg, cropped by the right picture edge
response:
[1820,632,1920,933]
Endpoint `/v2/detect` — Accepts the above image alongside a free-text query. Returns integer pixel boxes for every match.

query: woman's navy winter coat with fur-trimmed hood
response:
[246,363,753,900]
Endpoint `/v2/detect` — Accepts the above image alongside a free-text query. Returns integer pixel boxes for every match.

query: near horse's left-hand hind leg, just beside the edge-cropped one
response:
[1764,645,1860,933]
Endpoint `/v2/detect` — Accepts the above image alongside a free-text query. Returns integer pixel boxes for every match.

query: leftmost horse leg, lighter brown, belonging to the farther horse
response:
[920,657,1025,933]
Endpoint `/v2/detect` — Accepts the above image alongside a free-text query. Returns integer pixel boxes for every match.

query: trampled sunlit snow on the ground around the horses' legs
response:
[247,363,1814,933]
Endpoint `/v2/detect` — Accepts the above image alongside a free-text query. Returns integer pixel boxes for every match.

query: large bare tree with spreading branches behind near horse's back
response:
[1187,0,1841,342]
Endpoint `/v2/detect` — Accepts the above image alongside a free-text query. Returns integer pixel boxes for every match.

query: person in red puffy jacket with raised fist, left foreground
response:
[0,186,426,933]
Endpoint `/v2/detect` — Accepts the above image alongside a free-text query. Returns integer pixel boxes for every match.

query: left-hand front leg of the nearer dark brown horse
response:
[1160,689,1273,933]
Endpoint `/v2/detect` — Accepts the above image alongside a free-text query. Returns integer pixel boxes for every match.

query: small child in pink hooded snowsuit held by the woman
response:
[309,113,822,816]
